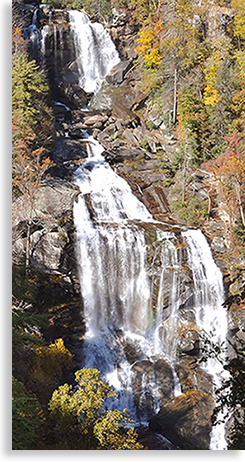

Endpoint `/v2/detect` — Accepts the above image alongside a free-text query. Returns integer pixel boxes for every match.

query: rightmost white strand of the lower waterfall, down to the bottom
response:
[183,230,228,449]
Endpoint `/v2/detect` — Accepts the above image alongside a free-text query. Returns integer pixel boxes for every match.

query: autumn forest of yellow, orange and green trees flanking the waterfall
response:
[12,0,245,450]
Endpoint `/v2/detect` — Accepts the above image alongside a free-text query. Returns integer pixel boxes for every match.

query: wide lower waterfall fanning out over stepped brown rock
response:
[74,151,227,449]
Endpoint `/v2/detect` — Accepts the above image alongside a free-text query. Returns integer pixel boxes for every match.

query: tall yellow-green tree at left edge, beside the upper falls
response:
[12,33,55,152]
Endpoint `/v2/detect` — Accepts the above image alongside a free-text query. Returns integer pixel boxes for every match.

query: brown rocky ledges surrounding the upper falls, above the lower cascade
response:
[29,7,176,223]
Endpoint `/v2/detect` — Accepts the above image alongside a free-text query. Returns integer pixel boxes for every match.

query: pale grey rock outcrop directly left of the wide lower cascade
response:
[13,178,80,293]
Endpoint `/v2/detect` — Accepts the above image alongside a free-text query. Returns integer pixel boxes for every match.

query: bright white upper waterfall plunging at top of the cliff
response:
[69,10,120,93]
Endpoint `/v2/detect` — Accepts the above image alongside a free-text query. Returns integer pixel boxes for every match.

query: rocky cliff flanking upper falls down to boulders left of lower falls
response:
[13,6,174,278]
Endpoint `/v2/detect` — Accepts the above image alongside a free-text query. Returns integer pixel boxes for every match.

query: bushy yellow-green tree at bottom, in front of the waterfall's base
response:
[49,368,142,449]
